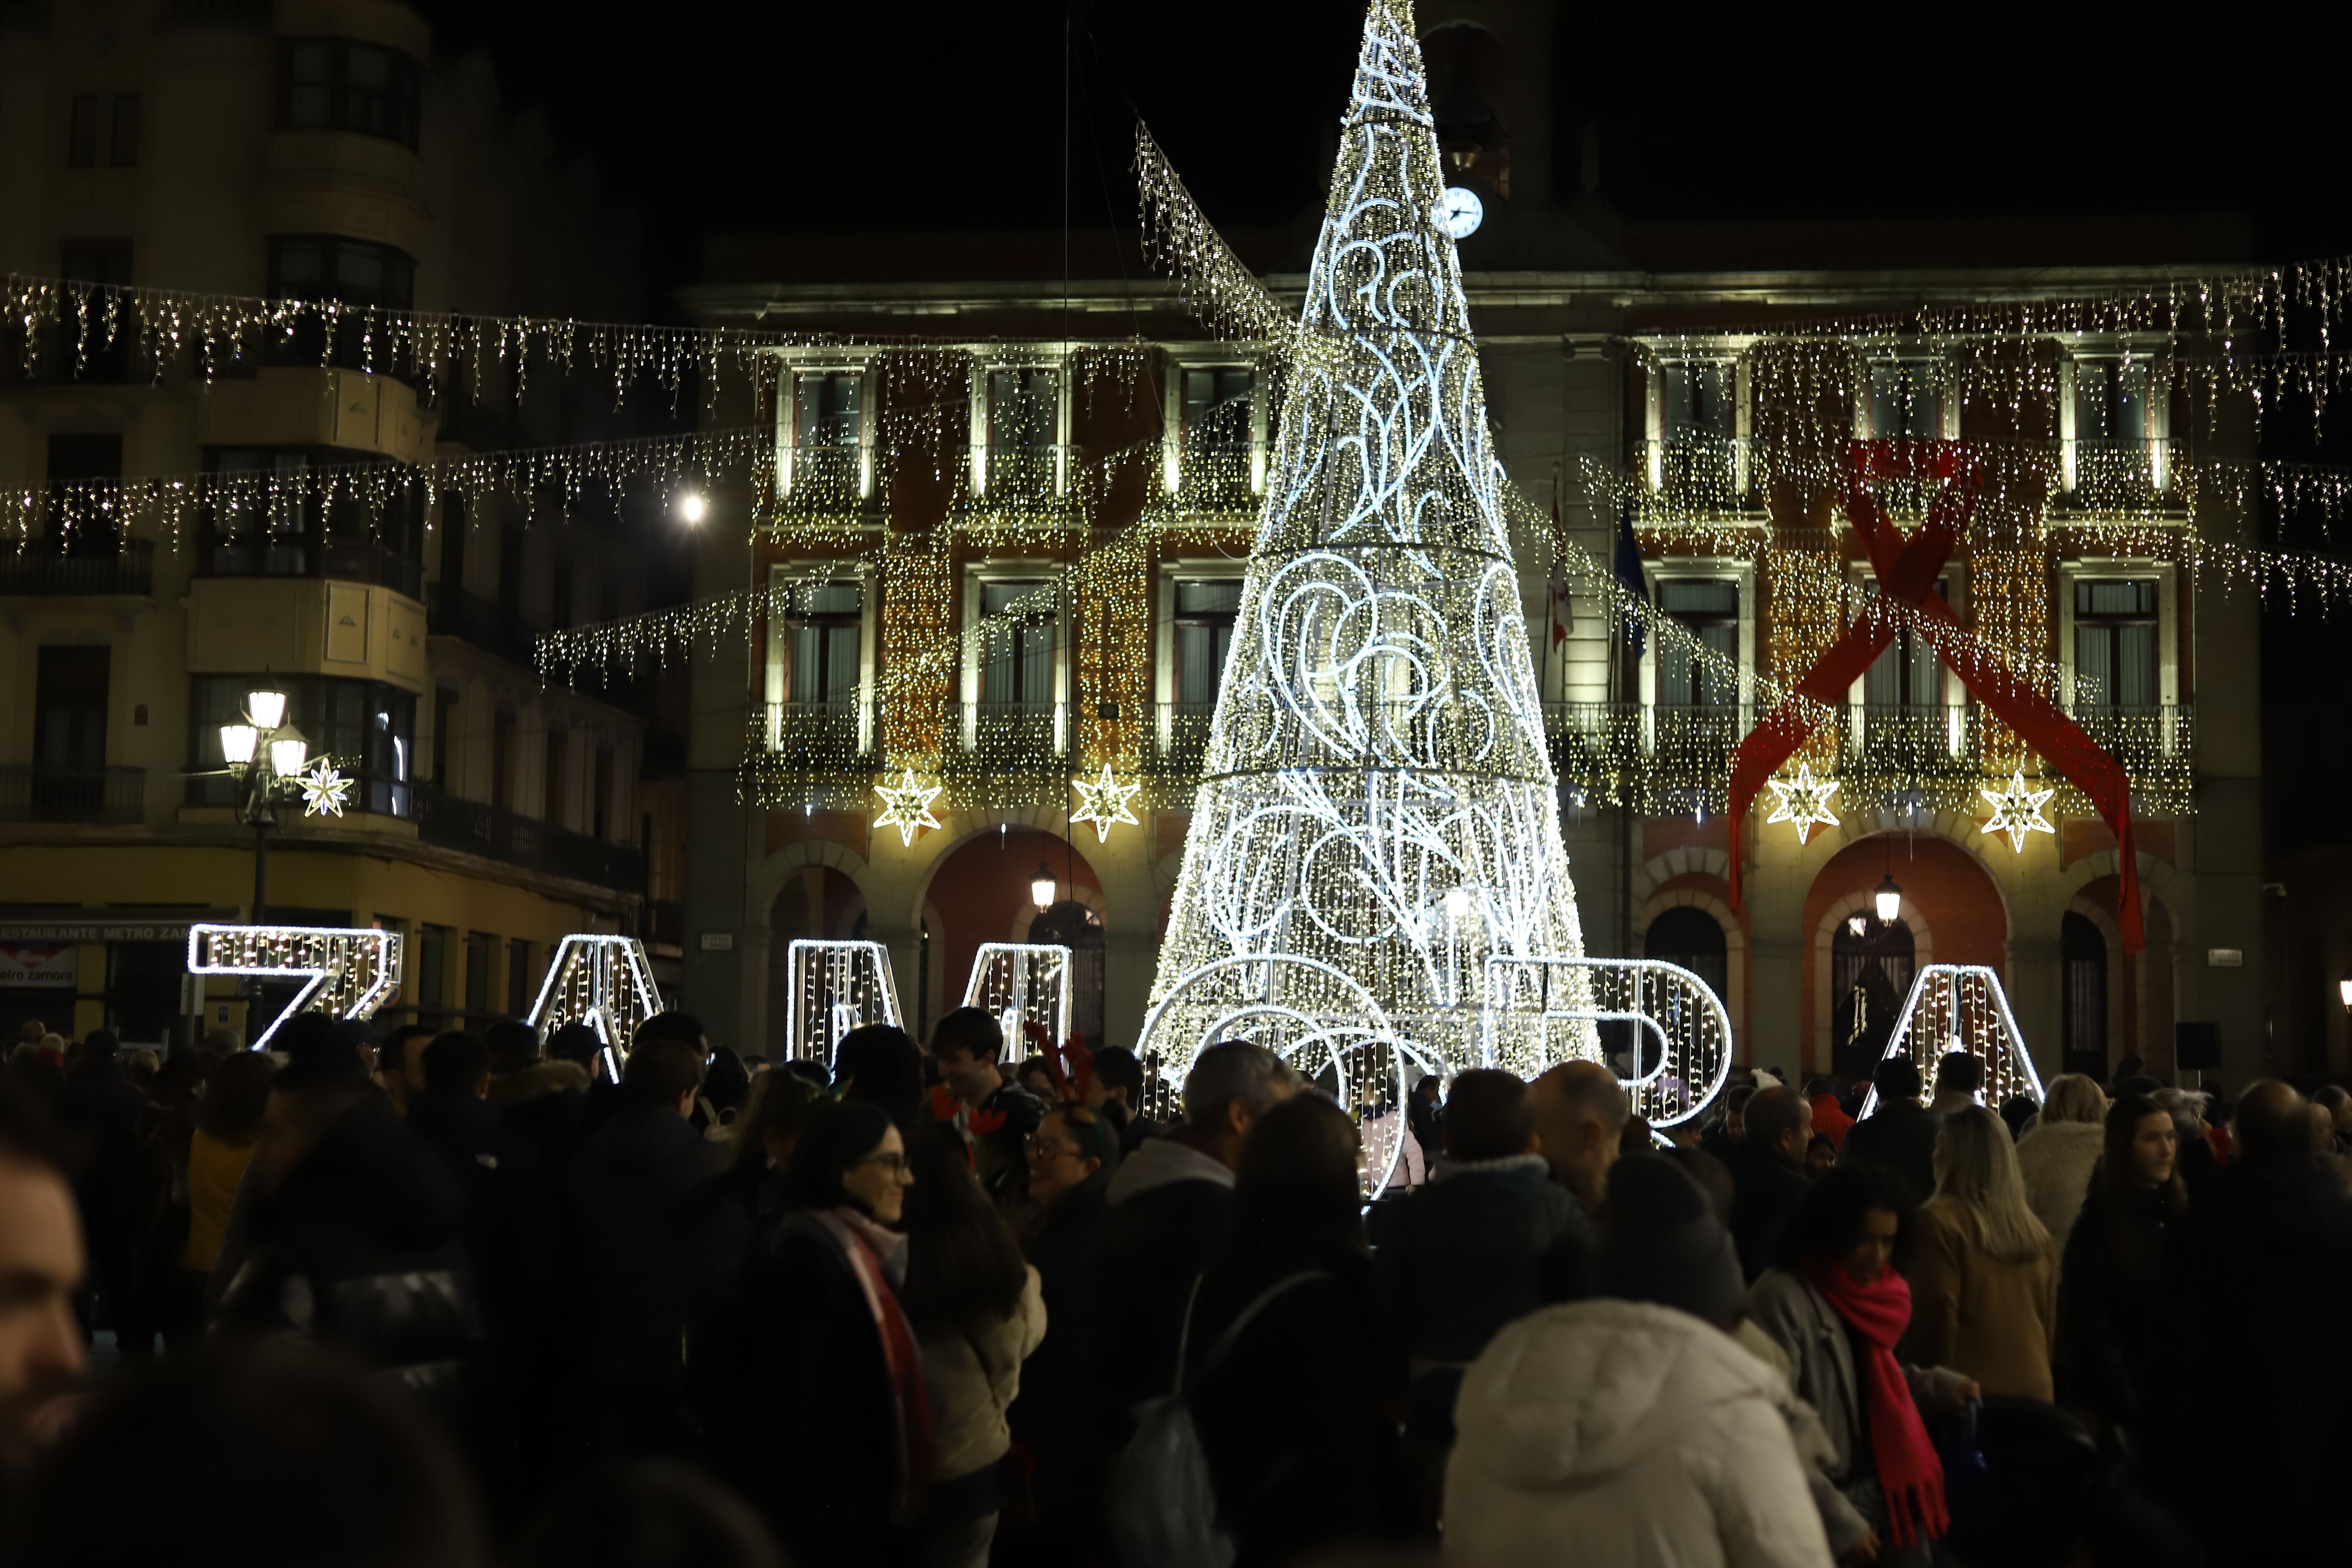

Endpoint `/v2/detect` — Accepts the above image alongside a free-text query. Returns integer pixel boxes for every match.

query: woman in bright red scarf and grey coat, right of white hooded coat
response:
[1747,1161,1978,1568]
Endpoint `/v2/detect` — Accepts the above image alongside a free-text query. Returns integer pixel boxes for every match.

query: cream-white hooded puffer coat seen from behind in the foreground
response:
[1447,1300,1830,1568]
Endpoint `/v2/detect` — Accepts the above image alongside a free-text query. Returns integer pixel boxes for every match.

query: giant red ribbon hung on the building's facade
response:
[1731,439,2145,952]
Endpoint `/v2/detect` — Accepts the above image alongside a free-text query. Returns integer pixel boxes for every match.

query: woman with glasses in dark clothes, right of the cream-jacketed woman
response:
[1011,1100,1119,1561]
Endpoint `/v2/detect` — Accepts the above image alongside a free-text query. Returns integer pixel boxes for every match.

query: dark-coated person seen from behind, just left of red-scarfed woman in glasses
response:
[569,1039,734,1455]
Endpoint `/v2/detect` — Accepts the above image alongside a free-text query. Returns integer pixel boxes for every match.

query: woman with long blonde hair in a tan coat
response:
[1903,1105,2058,1399]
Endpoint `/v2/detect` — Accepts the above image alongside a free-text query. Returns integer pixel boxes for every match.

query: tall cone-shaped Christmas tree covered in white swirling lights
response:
[1143,0,1597,1128]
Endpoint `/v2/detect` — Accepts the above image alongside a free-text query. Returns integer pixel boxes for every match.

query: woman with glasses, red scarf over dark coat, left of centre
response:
[741,1102,936,1568]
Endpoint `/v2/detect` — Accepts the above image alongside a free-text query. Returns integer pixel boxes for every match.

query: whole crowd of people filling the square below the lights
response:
[0,1009,2352,1568]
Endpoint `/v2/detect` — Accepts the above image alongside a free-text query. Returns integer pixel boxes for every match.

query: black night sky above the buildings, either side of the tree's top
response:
[423,0,2352,313]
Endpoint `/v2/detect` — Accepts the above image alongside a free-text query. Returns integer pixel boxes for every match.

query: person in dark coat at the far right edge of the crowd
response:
[2150,1081,2352,1568]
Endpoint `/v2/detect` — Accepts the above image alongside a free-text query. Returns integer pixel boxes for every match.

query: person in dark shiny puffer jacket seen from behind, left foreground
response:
[216,1041,480,1420]
